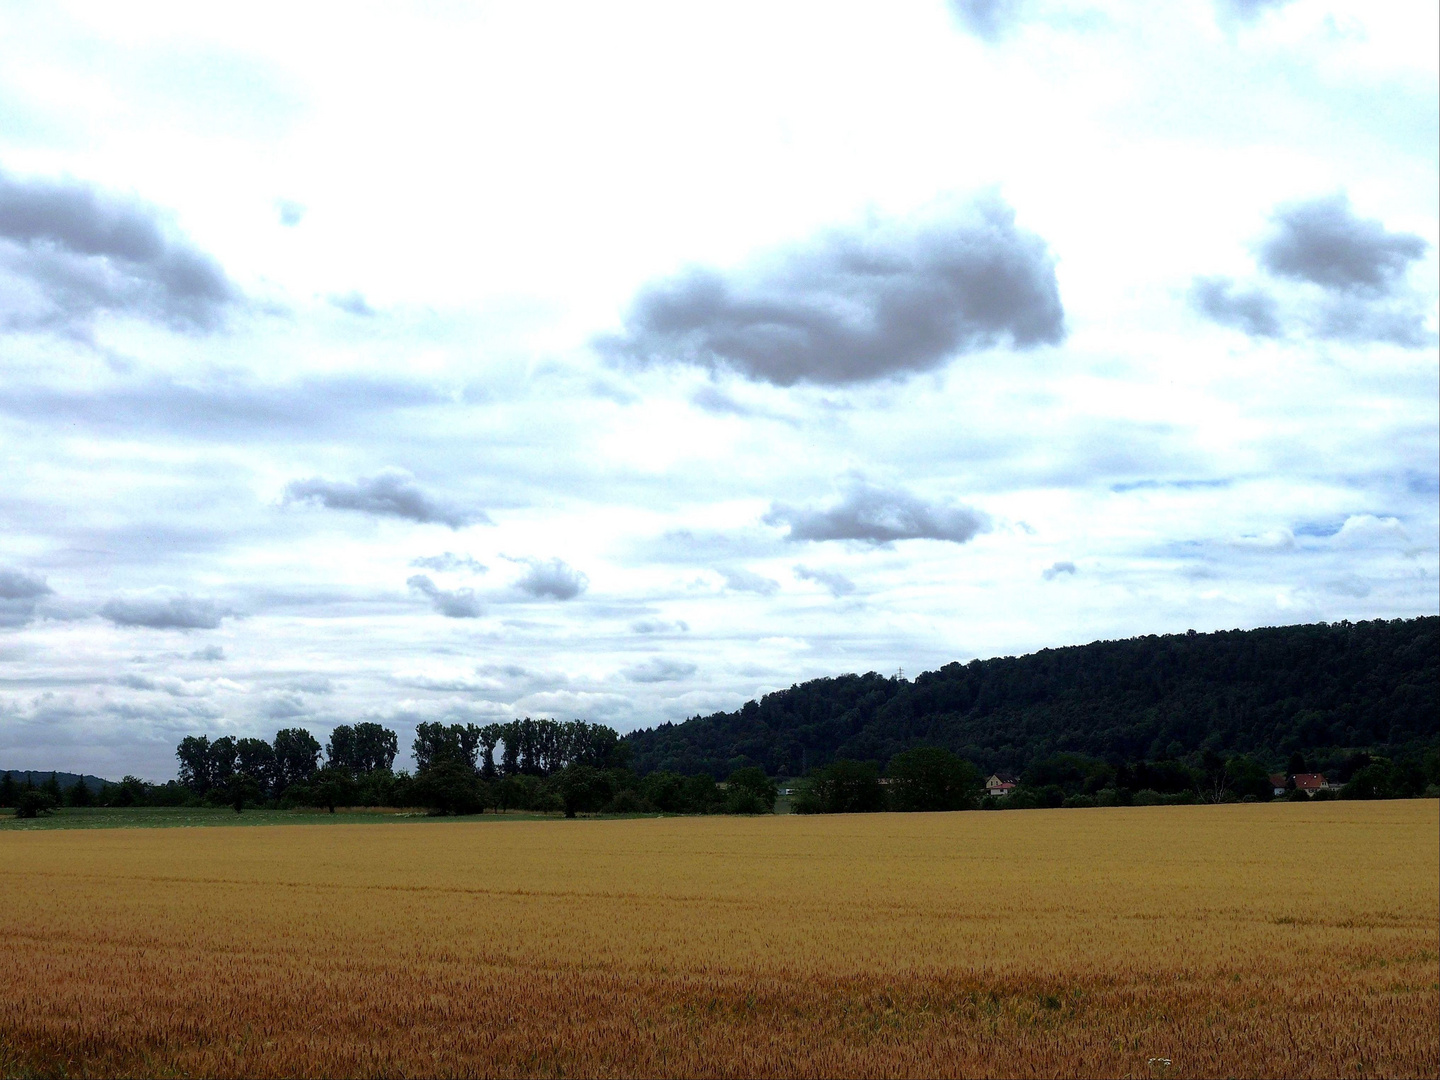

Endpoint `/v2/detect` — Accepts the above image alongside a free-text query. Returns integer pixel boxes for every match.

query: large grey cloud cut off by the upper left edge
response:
[0,166,240,333]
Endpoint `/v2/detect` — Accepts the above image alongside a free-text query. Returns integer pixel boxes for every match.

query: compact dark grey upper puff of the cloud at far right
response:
[1260,193,1428,294]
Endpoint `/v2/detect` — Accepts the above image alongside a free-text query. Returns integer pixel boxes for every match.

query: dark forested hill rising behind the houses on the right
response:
[626,616,1440,778]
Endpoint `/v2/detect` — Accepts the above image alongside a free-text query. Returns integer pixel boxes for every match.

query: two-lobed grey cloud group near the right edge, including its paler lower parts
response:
[1189,193,1434,348]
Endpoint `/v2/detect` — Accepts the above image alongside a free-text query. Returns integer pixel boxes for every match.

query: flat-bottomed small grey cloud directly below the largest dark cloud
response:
[763,482,991,544]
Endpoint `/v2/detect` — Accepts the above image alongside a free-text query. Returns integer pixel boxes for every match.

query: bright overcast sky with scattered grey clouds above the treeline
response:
[0,0,1440,779]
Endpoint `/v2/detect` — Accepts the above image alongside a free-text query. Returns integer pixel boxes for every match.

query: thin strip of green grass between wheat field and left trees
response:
[0,806,553,832]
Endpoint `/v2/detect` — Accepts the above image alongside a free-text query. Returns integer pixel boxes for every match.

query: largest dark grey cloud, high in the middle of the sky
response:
[596,199,1064,386]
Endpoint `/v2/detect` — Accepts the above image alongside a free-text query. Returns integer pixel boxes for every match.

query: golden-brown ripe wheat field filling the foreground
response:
[0,801,1440,1077]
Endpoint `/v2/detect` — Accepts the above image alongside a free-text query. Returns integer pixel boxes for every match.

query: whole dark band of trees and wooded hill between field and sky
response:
[0,616,1440,816]
